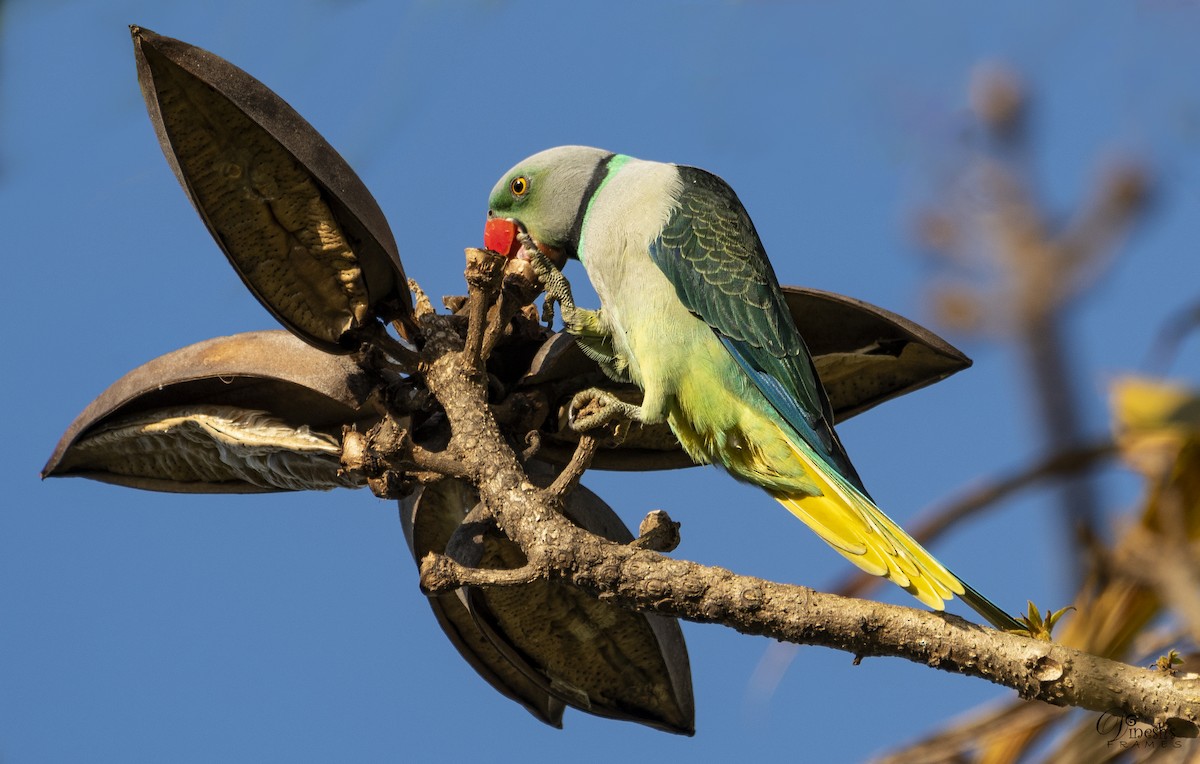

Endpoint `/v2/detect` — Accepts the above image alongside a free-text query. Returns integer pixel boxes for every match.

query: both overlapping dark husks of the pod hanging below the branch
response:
[401,467,695,735]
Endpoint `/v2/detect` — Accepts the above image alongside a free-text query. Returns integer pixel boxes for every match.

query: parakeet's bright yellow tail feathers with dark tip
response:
[773,444,1020,630]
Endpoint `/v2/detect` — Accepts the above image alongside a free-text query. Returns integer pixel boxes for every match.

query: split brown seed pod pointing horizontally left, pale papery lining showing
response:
[42,331,379,493]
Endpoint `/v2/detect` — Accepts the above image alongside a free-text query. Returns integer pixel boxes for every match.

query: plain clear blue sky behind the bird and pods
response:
[9,0,1200,763]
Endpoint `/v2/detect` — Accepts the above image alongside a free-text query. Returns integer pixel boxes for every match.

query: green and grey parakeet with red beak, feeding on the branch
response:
[485,146,1020,628]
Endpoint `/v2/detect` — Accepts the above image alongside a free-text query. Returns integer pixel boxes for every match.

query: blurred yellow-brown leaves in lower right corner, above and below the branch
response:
[888,377,1200,764]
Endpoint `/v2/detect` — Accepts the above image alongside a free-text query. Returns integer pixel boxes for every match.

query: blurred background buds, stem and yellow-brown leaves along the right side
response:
[873,65,1200,764]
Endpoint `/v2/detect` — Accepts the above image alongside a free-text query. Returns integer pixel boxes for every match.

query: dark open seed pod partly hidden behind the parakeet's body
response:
[521,287,971,470]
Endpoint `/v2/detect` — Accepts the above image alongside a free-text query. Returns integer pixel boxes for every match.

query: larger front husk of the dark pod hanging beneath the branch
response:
[446,470,695,735]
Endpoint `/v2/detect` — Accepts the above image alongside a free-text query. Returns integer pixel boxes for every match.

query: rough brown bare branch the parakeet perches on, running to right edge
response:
[396,260,1200,736]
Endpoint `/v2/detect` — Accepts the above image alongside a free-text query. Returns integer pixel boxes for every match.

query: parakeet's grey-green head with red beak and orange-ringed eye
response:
[484,146,612,266]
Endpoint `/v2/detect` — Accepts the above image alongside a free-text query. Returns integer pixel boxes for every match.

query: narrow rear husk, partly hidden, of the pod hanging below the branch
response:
[400,477,565,729]
